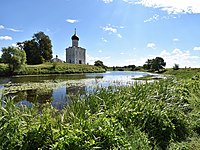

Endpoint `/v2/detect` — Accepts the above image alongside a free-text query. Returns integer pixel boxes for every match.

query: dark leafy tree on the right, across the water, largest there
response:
[143,57,166,71]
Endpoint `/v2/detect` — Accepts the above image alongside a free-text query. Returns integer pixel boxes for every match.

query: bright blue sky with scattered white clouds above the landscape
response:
[0,0,200,68]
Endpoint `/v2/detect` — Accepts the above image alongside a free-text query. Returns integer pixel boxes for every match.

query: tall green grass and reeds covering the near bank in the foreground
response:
[0,72,200,150]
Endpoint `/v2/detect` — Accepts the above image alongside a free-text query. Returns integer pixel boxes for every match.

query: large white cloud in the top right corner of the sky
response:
[135,0,200,14]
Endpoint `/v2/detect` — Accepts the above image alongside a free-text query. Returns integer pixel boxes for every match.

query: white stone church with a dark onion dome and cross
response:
[66,30,86,64]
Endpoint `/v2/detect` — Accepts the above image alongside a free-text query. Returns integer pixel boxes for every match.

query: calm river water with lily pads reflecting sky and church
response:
[0,71,152,109]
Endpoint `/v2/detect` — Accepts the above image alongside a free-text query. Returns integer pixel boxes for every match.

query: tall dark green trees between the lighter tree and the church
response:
[17,32,53,65]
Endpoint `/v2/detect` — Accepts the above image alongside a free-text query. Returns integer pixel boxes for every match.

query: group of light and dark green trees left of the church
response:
[0,32,53,72]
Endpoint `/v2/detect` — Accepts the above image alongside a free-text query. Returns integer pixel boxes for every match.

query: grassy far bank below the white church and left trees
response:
[0,63,105,76]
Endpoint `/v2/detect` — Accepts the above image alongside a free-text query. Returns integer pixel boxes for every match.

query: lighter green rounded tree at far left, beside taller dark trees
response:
[1,47,26,73]
